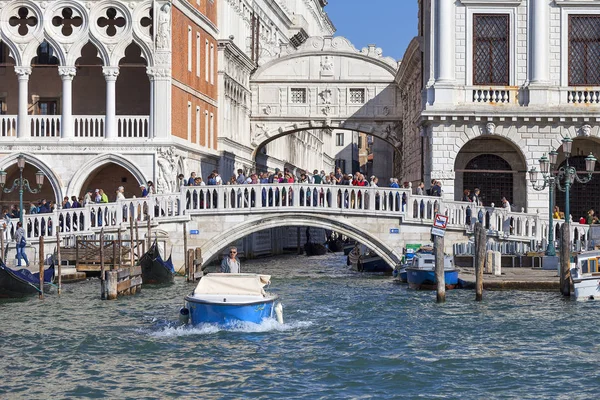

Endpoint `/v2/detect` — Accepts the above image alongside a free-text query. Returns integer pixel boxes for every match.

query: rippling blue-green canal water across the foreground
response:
[0,255,600,399]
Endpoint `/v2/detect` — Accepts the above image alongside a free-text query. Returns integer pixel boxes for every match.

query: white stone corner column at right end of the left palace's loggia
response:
[146,67,171,139]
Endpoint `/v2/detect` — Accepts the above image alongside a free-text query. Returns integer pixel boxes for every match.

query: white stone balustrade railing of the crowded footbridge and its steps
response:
[3,183,589,250]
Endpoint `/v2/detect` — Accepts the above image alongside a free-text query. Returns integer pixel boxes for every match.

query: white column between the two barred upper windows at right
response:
[529,0,550,84]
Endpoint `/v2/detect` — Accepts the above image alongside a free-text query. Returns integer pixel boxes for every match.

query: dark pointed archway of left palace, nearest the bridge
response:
[79,163,141,202]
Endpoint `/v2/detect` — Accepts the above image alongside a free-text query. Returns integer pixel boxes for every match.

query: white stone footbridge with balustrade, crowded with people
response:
[9,183,589,265]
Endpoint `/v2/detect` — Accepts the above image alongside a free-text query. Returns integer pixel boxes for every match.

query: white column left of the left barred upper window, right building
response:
[435,0,455,82]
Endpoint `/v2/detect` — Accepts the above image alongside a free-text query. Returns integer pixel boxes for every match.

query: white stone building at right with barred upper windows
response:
[397,0,600,219]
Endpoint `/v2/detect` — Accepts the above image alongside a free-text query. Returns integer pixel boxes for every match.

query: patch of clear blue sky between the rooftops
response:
[325,0,419,59]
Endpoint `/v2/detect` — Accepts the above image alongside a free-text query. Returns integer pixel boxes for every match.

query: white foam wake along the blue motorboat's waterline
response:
[150,318,313,337]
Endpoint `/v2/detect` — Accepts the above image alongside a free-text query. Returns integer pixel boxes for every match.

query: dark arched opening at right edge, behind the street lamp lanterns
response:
[556,156,600,222]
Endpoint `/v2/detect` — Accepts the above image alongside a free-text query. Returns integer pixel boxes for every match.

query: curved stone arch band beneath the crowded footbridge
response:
[202,213,402,266]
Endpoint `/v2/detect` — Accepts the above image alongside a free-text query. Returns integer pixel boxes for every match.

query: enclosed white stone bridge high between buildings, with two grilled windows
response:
[250,37,402,160]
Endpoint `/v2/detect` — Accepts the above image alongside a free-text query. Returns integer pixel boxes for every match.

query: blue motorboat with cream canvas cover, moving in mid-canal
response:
[180,273,283,325]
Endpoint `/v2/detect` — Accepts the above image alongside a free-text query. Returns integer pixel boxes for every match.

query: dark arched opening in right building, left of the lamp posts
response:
[463,154,514,207]
